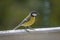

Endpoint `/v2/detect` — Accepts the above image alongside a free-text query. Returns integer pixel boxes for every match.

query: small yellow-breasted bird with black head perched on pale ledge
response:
[13,11,37,30]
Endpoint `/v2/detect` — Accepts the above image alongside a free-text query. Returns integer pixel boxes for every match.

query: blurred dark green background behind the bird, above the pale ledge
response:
[0,0,60,30]
